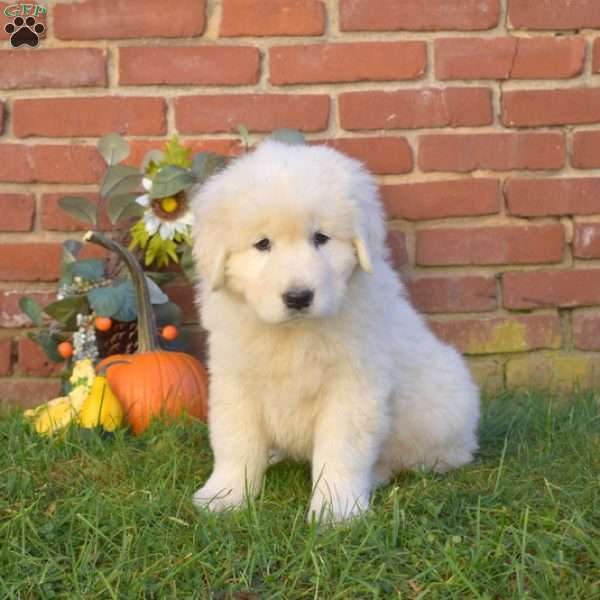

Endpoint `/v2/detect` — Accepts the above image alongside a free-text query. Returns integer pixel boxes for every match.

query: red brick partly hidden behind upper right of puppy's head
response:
[323,137,413,175]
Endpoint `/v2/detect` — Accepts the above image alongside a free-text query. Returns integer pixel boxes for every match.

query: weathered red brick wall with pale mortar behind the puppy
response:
[0,0,600,404]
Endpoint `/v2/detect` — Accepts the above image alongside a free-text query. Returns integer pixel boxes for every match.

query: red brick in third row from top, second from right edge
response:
[338,88,493,129]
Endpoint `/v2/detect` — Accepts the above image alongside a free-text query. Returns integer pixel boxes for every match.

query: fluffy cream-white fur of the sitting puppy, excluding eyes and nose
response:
[193,142,479,521]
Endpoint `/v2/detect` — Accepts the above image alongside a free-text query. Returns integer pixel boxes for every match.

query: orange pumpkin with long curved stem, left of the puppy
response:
[85,231,208,434]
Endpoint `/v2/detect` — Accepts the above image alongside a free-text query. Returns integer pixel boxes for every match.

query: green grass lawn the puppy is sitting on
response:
[0,394,600,600]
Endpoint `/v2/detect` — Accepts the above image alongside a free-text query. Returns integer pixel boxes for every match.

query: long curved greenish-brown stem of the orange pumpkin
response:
[83,231,159,353]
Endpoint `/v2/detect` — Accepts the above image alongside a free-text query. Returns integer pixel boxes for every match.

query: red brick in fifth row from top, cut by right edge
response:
[504,177,600,217]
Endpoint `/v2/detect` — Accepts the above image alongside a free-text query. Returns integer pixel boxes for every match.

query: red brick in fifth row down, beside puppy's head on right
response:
[382,179,500,221]
